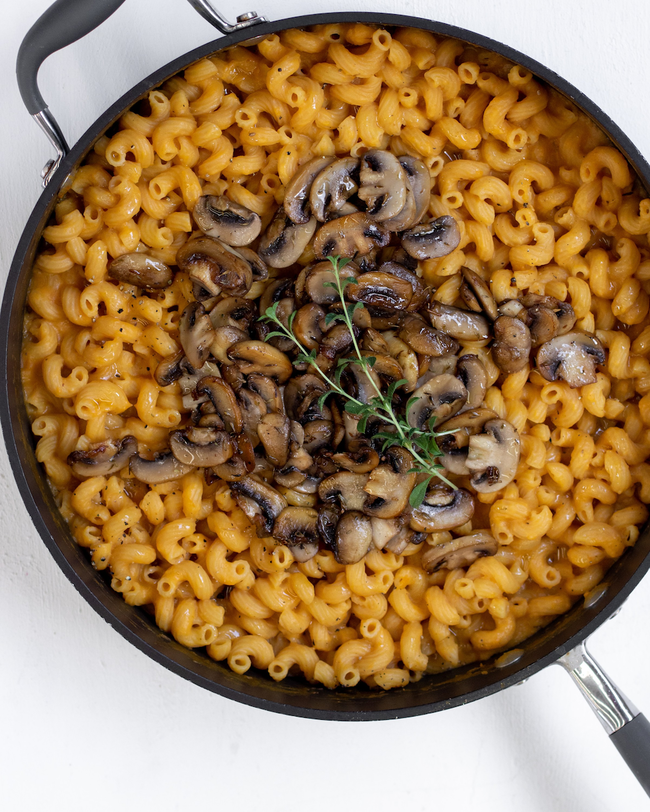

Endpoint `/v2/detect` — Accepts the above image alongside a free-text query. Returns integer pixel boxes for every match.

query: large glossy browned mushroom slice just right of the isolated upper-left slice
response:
[176,235,253,296]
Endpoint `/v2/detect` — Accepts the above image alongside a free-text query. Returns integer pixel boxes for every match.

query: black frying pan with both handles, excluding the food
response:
[5,0,650,794]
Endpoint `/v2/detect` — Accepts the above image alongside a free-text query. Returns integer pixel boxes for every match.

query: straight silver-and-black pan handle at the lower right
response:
[558,643,650,795]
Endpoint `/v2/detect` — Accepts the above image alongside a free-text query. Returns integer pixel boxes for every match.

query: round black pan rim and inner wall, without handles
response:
[2,14,650,720]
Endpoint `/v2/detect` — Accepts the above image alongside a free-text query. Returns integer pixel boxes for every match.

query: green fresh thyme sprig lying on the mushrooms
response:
[262,257,456,507]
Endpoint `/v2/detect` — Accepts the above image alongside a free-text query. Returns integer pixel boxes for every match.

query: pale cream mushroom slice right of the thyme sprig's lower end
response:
[465,417,521,493]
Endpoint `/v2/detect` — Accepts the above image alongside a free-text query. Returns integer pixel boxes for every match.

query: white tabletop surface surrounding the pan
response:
[0,0,650,812]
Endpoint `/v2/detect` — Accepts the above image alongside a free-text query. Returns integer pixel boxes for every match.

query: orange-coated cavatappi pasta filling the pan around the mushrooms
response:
[23,24,650,689]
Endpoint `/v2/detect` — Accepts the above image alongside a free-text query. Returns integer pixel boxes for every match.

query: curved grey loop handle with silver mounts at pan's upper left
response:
[16,0,266,186]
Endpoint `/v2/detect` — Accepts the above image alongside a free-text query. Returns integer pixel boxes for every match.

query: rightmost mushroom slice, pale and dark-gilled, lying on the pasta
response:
[537,330,605,389]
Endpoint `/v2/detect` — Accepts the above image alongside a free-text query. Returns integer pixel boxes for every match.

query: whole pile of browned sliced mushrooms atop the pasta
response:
[68,150,605,572]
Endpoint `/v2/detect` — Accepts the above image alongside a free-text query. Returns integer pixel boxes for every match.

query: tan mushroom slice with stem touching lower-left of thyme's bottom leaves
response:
[363,446,417,519]
